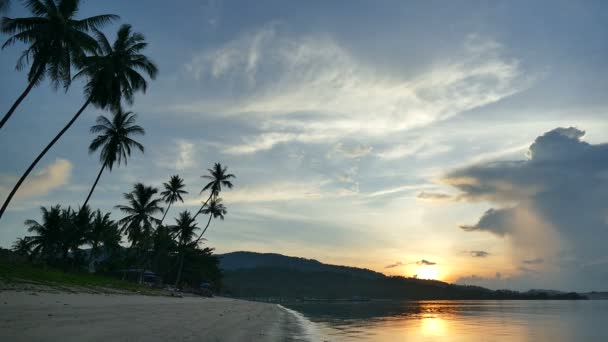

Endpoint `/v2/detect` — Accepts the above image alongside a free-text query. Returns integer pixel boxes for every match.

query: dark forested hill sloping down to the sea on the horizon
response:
[218,252,585,299]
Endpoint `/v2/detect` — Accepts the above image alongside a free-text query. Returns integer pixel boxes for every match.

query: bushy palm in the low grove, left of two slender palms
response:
[115,183,163,247]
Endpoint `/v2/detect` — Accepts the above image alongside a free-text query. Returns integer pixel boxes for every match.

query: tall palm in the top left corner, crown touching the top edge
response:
[0,0,119,129]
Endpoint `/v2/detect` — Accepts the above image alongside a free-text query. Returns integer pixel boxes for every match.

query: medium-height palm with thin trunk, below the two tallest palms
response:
[83,109,145,206]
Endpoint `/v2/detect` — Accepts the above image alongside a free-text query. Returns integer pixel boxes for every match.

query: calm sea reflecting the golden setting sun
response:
[283,300,608,342]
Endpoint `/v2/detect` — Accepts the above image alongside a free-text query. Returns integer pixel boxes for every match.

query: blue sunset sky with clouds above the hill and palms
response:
[0,0,608,291]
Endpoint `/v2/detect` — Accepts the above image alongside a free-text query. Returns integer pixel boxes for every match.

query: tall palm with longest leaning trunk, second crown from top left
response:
[0,25,158,219]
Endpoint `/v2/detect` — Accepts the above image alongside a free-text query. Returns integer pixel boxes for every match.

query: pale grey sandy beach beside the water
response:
[0,291,300,342]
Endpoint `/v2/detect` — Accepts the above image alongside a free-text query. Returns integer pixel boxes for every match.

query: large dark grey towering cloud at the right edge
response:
[444,127,608,288]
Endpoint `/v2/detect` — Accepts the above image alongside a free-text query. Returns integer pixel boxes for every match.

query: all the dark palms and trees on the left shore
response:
[0,0,234,285]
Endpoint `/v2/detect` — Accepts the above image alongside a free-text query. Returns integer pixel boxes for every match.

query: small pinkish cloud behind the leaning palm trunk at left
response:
[0,159,72,199]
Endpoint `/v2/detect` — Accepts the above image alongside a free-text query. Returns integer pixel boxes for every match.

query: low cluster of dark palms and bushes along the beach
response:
[13,163,235,286]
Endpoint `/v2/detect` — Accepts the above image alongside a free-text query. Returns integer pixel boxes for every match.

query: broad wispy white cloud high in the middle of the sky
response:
[182,23,529,154]
